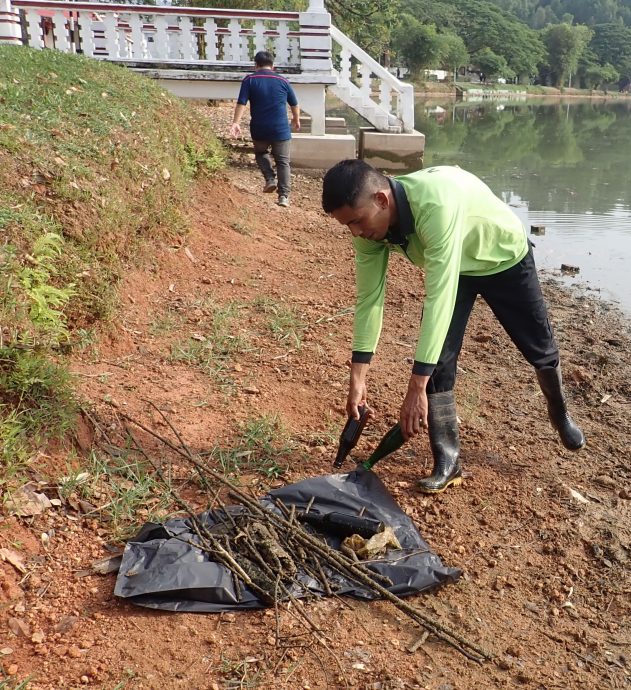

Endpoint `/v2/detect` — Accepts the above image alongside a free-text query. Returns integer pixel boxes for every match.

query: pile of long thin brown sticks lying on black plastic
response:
[121,408,494,663]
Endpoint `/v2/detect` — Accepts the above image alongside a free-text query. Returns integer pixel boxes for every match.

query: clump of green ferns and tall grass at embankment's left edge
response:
[0,232,76,468]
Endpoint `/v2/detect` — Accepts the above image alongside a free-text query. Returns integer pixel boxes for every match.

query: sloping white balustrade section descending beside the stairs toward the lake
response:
[331,26,414,132]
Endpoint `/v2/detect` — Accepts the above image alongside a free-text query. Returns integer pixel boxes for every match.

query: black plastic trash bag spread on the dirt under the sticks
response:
[114,469,460,613]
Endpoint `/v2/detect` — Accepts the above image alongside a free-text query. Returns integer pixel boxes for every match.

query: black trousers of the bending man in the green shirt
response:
[427,246,559,393]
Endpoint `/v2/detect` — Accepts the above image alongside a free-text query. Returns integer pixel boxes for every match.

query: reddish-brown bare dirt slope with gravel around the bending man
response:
[0,148,631,690]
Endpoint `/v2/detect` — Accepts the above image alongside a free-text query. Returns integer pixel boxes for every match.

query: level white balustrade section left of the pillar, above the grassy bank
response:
[11,0,301,68]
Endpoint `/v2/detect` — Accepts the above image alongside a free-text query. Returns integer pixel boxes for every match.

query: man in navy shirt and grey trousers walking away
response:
[230,51,300,206]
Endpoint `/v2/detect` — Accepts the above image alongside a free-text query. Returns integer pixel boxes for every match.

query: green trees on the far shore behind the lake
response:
[191,0,631,88]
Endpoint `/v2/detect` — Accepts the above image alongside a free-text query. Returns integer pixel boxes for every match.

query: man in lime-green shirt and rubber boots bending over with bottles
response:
[322,160,585,493]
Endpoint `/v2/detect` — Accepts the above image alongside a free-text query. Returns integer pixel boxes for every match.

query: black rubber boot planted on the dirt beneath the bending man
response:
[418,391,462,494]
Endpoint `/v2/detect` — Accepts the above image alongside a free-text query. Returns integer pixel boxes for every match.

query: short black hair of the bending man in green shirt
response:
[322,158,388,213]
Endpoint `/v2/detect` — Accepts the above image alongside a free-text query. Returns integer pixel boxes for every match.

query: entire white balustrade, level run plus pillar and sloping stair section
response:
[0,0,414,134]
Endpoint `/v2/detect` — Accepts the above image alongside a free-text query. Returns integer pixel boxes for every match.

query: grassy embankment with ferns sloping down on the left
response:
[0,46,224,483]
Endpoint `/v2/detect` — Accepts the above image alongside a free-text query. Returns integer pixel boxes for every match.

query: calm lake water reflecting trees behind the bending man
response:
[330,99,631,315]
